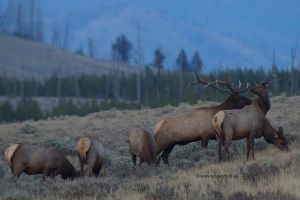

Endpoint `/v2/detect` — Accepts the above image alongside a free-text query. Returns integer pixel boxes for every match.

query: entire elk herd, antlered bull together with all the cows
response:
[4,67,288,179]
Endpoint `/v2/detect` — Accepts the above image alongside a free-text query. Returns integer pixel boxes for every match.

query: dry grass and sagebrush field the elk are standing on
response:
[0,97,300,200]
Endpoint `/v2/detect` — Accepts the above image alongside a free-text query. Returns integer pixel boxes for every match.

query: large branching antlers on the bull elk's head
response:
[188,67,250,94]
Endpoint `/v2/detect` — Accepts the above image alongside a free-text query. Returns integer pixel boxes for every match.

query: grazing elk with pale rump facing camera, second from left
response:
[76,137,107,177]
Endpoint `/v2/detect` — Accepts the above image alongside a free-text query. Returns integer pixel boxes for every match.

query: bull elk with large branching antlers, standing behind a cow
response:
[154,70,251,164]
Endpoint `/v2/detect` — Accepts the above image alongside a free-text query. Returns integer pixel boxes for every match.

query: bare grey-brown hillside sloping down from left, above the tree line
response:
[0,33,133,79]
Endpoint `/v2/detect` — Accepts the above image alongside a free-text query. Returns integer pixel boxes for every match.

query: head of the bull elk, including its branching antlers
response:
[188,68,252,109]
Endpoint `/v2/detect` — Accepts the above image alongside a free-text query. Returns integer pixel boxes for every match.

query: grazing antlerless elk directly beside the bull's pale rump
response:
[128,127,157,165]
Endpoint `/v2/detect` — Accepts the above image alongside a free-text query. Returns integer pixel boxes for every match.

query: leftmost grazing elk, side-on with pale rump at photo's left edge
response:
[5,144,77,179]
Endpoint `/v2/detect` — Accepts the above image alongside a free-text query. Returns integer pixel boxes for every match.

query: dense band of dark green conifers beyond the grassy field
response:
[0,66,300,121]
